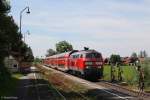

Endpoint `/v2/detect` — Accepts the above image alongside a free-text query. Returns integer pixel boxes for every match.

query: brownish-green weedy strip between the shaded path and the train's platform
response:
[41,69,89,100]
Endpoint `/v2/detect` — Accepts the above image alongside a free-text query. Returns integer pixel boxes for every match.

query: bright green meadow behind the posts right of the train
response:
[103,64,150,91]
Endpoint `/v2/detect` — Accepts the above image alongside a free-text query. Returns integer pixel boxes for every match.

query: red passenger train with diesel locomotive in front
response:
[43,50,103,80]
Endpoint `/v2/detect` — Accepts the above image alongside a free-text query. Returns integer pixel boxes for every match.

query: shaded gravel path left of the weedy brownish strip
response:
[15,67,65,100]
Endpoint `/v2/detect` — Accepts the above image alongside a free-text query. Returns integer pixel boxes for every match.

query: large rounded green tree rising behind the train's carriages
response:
[56,41,73,53]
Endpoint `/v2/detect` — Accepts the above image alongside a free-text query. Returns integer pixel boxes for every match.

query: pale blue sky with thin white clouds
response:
[10,0,150,57]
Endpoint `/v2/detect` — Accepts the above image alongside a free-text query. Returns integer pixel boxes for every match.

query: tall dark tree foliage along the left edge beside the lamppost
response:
[0,0,33,84]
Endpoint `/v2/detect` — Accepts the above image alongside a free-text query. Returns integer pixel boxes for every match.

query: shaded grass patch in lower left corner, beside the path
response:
[0,73,23,96]
